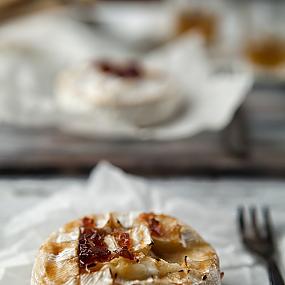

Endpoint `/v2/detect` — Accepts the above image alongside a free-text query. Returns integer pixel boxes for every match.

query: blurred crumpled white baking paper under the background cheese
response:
[0,9,253,140]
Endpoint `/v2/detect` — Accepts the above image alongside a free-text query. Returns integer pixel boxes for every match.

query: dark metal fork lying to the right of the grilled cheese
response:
[238,207,285,285]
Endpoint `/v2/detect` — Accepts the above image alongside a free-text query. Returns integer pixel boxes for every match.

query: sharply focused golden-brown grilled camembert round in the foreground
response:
[31,212,221,285]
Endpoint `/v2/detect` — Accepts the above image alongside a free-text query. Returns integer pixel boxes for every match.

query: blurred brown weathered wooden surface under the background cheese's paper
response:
[0,82,285,176]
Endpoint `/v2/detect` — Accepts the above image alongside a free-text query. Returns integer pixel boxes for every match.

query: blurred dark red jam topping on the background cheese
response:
[95,60,143,79]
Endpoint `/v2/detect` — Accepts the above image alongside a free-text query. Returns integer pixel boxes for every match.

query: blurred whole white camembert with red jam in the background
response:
[56,60,183,126]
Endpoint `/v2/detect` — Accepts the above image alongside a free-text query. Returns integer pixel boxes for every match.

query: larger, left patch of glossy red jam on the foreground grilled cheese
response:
[78,217,135,271]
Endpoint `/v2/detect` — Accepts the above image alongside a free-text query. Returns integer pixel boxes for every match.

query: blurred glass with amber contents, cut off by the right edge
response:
[242,0,285,70]
